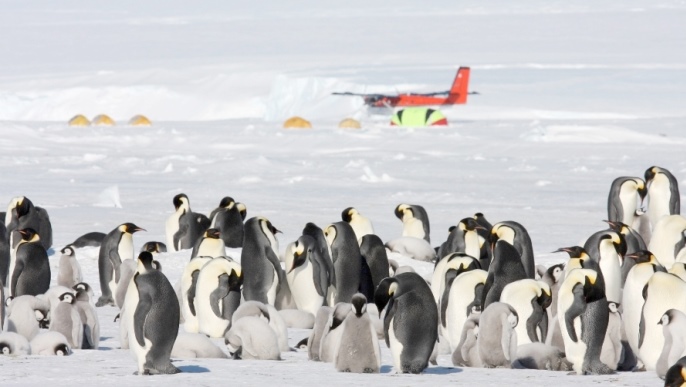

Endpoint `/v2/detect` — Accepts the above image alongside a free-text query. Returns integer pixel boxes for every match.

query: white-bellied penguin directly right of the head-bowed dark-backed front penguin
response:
[440,269,488,352]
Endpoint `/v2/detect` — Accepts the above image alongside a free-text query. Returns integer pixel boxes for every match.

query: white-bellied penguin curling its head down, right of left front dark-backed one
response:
[194,256,243,338]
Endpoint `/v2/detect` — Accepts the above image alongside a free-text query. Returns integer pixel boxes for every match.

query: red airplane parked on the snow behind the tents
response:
[333,67,477,108]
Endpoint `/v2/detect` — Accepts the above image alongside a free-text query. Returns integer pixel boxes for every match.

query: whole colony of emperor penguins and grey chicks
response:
[0,167,686,386]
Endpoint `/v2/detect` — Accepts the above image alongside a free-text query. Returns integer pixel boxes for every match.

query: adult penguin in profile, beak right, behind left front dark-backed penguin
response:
[95,223,145,306]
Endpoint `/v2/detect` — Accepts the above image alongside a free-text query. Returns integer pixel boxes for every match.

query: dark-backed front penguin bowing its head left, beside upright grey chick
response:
[374,273,438,374]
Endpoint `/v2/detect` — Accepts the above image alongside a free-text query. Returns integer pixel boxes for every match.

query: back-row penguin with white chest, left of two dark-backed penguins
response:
[165,194,210,251]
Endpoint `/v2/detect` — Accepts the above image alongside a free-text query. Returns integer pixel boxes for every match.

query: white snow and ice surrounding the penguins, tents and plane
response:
[0,0,686,386]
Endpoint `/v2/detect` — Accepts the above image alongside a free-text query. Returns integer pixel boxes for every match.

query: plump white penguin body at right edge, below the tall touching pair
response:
[648,215,686,270]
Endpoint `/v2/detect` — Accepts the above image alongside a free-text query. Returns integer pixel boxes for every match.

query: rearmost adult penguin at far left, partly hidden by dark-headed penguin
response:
[5,196,52,251]
